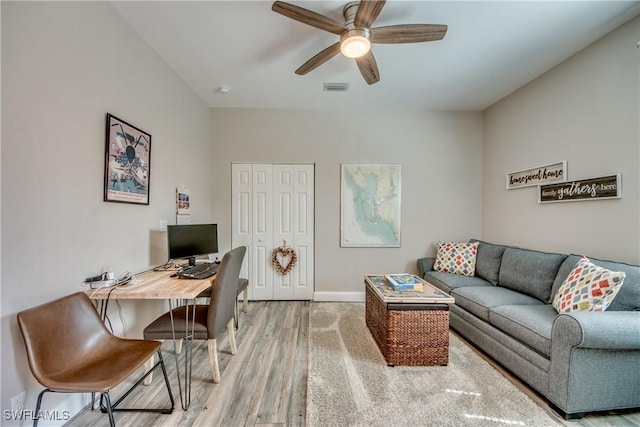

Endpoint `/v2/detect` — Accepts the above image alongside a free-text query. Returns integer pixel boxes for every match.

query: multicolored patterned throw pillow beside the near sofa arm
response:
[553,257,626,313]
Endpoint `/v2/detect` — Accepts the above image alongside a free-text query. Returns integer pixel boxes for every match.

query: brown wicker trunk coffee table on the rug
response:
[364,275,455,366]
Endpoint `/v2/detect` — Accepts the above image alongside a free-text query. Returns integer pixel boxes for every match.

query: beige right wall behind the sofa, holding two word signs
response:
[482,18,640,264]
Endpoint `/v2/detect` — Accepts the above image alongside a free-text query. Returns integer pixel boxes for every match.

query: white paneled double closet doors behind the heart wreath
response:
[231,163,314,300]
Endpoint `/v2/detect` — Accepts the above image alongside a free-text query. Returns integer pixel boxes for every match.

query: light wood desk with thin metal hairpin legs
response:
[86,270,216,411]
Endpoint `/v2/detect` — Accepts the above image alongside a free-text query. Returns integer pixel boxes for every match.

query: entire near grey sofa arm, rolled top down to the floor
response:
[547,311,640,415]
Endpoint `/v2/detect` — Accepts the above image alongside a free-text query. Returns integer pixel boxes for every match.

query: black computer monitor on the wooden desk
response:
[167,224,218,265]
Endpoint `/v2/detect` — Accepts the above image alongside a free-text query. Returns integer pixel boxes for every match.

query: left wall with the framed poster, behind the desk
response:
[0,1,211,425]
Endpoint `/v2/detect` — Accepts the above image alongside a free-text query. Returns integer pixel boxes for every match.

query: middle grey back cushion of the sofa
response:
[498,247,566,303]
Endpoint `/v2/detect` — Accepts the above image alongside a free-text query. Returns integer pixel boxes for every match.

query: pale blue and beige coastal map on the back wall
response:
[340,164,401,248]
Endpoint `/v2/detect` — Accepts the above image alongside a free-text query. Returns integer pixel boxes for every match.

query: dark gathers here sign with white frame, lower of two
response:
[538,174,622,203]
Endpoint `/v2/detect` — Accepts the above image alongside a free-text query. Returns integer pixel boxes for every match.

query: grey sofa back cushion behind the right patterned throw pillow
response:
[551,255,640,311]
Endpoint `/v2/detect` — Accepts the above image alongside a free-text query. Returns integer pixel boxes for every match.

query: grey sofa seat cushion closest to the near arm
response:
[489,304,558,357]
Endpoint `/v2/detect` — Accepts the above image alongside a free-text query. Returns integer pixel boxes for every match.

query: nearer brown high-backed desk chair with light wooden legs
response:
[144,246,247,383]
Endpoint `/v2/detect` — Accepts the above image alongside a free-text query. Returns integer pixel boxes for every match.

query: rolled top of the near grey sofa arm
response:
[551,311,640,350]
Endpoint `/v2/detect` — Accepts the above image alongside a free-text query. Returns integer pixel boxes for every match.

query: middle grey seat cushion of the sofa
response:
[451,286,542,322]
